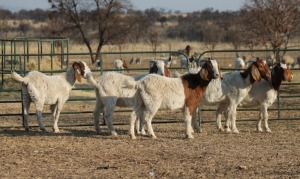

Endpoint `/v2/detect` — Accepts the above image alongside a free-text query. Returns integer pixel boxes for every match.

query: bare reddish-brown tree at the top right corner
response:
[242,0,300,59]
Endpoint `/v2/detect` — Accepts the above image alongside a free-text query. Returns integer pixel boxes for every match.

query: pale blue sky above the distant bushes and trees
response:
[0,0,244,12]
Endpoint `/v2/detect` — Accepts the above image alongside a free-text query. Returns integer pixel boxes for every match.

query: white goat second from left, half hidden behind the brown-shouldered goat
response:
[88,60,168,135]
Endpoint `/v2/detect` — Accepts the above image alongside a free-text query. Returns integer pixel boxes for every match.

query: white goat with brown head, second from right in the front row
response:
[205,58,270,133]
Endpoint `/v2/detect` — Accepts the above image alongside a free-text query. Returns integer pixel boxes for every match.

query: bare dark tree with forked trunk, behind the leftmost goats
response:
[49,0,136,63]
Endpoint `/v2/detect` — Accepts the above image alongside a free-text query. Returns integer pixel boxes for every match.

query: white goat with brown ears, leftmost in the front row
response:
[12,62,91,132]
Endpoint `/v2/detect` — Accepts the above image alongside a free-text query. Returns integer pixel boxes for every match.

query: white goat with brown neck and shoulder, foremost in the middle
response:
[124,60,220,139]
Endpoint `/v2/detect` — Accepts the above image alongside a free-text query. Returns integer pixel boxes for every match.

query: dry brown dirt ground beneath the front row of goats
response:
[0,116,300,179]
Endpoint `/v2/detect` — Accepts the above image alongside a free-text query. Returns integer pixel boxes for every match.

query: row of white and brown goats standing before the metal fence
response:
[12,55,293,139]
